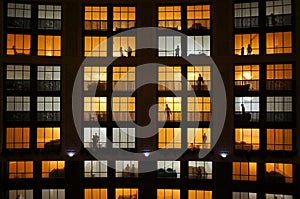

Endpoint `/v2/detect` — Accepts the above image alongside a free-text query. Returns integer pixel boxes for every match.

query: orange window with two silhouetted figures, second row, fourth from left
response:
[113,36,135,57]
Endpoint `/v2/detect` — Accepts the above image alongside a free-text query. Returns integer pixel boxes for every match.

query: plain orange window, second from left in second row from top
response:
[37,35,61,56]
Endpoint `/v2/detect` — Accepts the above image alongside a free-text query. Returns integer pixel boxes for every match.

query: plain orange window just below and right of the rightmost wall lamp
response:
[232,162,257,181]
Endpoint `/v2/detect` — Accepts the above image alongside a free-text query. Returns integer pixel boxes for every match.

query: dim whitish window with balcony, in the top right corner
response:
[266,0,292,27]
